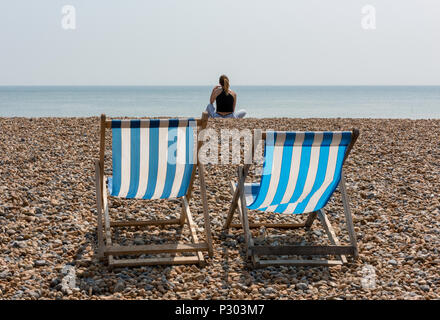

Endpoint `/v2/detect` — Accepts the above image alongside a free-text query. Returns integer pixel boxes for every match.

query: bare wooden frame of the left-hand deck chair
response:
[95,112,213,267]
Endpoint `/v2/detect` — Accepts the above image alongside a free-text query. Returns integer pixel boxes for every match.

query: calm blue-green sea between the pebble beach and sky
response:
[0,86,440,119]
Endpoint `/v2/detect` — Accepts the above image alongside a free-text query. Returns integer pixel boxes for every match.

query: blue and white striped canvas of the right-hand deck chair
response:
[244,131,352,214]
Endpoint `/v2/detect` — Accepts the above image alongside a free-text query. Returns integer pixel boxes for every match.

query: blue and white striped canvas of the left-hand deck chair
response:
[108,119,197,199]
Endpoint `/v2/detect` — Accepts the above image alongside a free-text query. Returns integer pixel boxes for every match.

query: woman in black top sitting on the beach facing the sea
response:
[206,75,246,118]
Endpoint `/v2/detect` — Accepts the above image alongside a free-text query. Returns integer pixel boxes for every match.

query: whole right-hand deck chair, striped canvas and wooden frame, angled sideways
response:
[224,129,359,267]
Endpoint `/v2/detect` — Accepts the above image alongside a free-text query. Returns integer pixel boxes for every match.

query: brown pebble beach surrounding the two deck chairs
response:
[0,117,440,300]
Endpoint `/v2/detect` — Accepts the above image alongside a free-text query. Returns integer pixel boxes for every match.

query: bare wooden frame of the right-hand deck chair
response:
[224,129,359,268]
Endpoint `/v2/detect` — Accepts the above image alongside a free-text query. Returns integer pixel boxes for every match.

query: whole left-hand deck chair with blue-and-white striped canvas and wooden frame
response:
[95,112,213,267]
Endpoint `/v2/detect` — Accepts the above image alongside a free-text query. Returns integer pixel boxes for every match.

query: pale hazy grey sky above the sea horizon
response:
[0,0,440,85]
